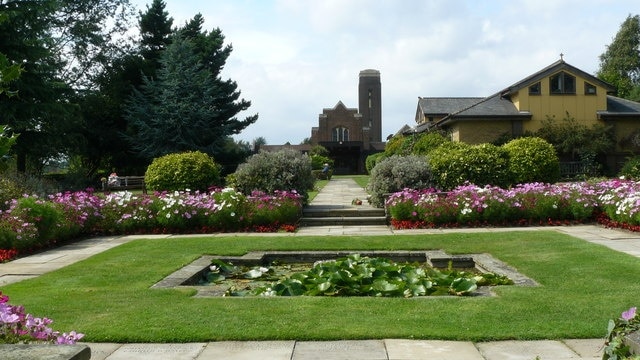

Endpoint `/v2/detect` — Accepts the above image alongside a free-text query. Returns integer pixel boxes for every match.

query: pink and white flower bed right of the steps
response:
[386,180,640,230]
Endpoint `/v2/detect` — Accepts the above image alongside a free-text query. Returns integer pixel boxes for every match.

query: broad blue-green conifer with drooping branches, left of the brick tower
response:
[126,27,258,159]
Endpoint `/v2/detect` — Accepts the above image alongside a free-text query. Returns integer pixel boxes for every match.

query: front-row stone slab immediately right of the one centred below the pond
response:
[384,339,484,360]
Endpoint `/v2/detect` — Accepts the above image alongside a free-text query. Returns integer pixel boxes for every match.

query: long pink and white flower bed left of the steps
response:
[0,188,302,261]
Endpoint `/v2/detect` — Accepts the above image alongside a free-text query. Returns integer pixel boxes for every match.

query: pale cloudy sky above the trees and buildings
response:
[132,0,640,145]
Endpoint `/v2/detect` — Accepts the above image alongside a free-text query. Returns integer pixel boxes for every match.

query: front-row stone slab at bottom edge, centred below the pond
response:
[291,340,388,360]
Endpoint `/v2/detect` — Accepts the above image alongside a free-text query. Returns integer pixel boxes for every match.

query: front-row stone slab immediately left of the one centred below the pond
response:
[199,340,296,360]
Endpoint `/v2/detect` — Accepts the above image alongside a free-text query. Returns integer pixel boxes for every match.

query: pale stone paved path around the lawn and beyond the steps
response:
[0,178,640,360]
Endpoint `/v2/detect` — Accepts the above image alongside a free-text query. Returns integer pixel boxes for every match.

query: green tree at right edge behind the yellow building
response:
[597,15,640,101]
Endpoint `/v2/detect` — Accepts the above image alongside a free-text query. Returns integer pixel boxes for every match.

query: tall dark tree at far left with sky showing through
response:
[0,0,128,172]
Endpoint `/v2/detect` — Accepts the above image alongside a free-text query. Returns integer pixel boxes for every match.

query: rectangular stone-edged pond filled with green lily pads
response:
[152,250,537,298]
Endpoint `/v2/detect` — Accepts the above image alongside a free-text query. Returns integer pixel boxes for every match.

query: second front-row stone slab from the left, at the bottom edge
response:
[99,343,207,360]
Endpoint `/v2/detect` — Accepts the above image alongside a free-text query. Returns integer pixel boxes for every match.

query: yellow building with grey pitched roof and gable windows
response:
[414,59,640,172]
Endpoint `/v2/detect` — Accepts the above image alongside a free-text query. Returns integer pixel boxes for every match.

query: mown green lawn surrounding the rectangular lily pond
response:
[2,231,640,342]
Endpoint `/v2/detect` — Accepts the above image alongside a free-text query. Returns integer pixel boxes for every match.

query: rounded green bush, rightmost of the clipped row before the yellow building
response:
[502,137,560,184]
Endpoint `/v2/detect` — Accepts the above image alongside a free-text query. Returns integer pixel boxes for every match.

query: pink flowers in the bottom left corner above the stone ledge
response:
[0,292,84,345]
